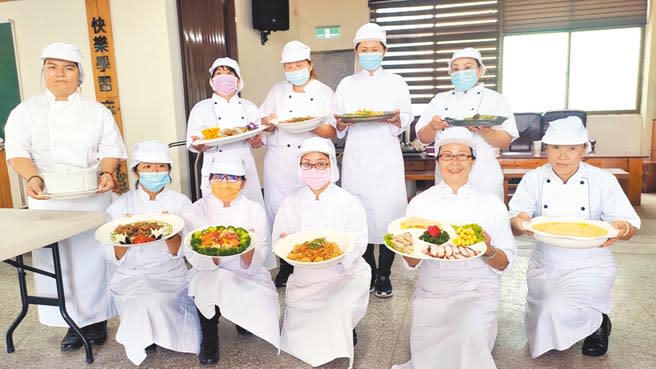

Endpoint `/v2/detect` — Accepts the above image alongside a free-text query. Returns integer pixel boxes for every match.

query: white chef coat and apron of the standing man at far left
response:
[5,90,127,327]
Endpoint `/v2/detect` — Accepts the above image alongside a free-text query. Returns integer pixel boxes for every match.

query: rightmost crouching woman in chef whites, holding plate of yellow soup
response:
[510,117,640,358]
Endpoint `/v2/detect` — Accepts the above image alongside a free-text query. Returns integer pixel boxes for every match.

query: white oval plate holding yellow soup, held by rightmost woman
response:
[524,216,619,249]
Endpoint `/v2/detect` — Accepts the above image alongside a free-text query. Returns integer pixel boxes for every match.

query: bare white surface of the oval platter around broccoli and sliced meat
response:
[385,217,487,262]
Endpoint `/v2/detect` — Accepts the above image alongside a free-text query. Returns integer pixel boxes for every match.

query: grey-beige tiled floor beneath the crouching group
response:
[0,195,656,369]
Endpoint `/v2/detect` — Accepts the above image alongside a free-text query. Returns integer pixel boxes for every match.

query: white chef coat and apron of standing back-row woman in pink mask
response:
[187,94,264,206]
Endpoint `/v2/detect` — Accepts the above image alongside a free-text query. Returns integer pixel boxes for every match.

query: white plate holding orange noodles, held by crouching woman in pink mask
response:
[273,231,355,269]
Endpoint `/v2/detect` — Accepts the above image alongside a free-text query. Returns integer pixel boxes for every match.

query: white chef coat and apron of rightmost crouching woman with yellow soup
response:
[509,163,640,358]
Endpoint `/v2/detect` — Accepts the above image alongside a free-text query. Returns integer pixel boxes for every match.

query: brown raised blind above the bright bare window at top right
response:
[503,0,648,33]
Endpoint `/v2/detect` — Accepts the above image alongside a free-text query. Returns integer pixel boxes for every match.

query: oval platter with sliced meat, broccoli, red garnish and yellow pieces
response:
[384,217,487,261]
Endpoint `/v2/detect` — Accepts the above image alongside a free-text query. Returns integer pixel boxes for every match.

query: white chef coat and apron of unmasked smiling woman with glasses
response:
[393,182,517,369]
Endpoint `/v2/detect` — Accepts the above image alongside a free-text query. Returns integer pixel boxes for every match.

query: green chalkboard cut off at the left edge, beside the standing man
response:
[0,21,20,139]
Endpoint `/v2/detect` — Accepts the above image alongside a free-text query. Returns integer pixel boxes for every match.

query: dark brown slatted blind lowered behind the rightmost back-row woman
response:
[369,0,500,104]
